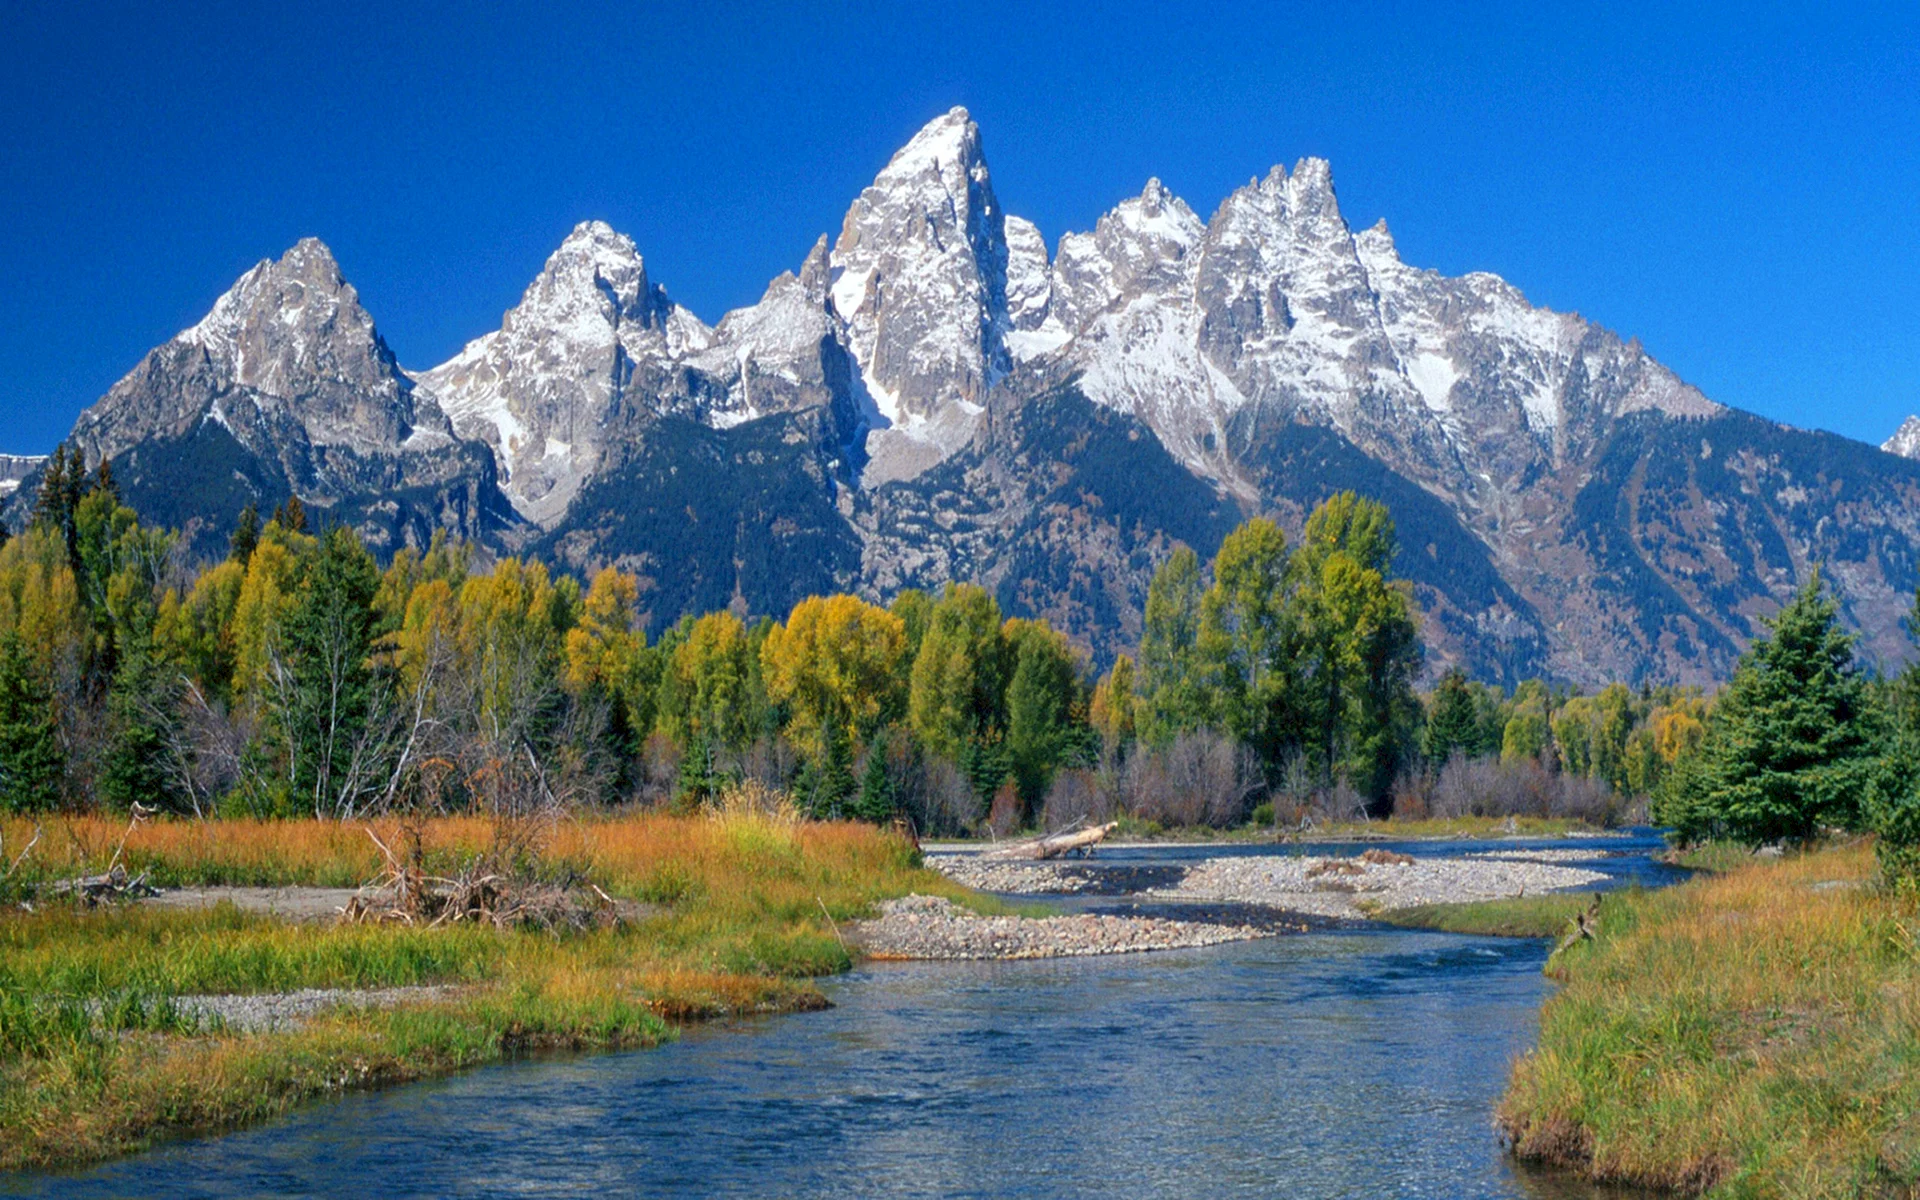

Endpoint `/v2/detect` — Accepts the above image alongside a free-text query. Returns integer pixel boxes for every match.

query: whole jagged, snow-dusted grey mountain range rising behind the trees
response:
[15,109,1920,684]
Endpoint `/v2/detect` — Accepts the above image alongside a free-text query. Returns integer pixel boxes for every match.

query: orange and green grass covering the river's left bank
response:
[0,814,967,1169]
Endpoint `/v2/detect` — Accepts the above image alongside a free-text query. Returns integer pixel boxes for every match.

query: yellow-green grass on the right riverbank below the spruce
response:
[1500,843,1920,1198]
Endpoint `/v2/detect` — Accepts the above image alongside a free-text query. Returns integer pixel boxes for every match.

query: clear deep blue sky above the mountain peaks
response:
[0,0,1920,451]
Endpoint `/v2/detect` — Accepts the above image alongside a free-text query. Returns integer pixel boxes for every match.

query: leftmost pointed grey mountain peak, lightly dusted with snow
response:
[6,238,511,553]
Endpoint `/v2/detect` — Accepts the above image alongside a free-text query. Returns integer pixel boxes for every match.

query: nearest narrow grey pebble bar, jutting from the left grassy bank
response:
[849,897,1275,958]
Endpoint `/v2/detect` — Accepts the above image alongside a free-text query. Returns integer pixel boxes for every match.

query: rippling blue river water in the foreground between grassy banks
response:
[0,843,1665,1198]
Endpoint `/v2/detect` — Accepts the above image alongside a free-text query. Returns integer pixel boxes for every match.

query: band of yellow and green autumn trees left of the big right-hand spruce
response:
[0,451,1891,852]
